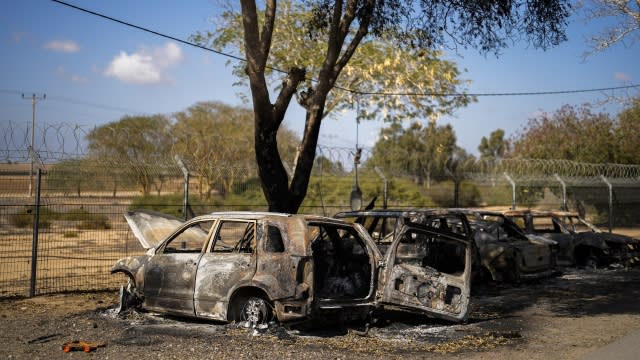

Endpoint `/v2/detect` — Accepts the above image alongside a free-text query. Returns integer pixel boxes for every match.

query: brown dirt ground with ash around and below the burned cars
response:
[0,269,640,360]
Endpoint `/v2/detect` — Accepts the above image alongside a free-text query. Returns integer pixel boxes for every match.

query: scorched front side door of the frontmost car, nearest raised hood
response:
[144,219,214,316]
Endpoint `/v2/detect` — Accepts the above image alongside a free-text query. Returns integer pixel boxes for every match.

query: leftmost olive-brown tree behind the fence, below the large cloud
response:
[87,115,172,195]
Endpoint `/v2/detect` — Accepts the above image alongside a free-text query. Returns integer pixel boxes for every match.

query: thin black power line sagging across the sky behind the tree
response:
[52,0,640,97]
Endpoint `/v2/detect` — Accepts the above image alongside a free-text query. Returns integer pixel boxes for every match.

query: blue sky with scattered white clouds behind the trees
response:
[0,0,640,159]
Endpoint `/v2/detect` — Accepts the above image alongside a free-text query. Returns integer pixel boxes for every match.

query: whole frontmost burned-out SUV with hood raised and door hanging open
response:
[111,212,470,326]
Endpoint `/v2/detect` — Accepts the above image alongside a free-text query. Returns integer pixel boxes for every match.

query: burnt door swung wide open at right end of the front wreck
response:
[379,224,472,321]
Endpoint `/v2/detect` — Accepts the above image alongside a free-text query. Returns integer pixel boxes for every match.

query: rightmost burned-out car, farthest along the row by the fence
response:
[504,210,640,268]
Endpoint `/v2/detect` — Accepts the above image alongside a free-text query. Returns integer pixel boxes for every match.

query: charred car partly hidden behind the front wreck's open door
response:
[335,209,555,282]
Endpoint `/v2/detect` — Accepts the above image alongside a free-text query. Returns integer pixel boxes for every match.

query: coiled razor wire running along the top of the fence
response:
[0,122,640,183]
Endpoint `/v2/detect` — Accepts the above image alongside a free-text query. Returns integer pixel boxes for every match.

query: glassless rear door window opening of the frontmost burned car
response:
[211,221,256,254]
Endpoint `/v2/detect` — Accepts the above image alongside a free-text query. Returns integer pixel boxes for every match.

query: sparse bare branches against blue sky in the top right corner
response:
[579,0,640,56]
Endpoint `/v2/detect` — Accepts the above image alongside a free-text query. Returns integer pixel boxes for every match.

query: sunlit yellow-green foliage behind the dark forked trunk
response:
[192,0,475,121]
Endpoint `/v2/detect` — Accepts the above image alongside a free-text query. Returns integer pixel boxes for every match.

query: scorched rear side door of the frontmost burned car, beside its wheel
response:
[193,219,259,320]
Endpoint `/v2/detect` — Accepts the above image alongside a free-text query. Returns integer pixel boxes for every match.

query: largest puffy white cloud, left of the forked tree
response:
[104,43,183,84]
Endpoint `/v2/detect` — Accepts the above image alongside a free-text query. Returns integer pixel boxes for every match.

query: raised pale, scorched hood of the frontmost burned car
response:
[124,210,184,250]
